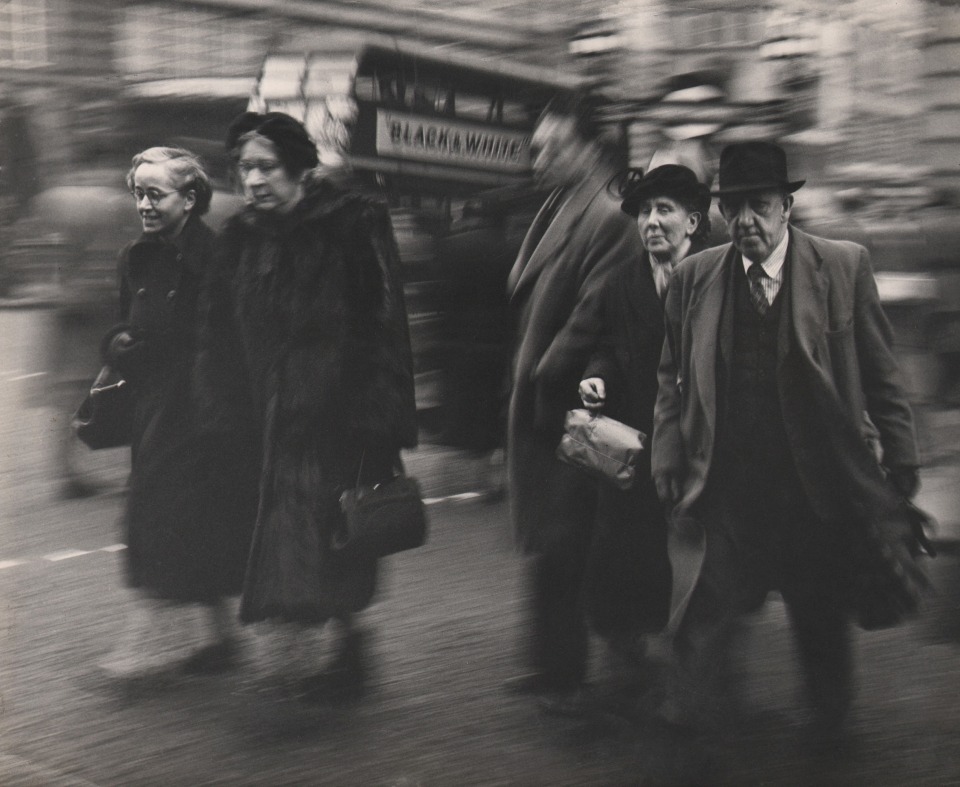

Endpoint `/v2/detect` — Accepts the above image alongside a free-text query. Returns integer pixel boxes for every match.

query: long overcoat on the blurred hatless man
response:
[508,168,643,552]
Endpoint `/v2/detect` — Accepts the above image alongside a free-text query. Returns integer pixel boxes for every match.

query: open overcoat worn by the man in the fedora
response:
[652,226,919,522]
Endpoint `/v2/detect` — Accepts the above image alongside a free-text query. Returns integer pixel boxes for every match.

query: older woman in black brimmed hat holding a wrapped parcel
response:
[580,164,710,683]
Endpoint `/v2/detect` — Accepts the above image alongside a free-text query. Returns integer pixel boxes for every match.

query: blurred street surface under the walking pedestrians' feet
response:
[0,310,960,787]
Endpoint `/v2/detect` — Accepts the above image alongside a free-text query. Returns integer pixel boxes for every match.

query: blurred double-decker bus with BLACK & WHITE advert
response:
[250,37,586,449]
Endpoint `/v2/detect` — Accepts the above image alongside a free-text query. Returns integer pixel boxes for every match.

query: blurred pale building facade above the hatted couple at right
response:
[592,0,960,204]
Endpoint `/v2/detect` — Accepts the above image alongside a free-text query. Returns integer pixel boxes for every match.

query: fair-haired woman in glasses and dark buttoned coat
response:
[102,147,256,674]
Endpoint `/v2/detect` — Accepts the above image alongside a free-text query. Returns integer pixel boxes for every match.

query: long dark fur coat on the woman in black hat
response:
[201,173,417,623]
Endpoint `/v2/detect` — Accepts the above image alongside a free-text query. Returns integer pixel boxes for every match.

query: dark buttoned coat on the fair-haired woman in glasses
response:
[103,218,256,601]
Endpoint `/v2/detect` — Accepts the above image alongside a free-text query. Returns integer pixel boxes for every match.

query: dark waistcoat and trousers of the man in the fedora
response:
[675,261,852,727]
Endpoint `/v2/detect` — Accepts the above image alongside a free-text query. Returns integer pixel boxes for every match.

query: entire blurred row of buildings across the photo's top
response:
[0,0,960,193]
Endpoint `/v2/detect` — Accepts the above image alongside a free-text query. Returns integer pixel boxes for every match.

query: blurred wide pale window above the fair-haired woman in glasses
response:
[115,0,270,79]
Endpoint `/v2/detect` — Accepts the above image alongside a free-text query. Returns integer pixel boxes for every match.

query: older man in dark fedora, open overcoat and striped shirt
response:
[651,142,919,742]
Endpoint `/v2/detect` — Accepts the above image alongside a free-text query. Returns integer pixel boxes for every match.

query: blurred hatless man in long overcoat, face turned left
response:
[507,96,643,713]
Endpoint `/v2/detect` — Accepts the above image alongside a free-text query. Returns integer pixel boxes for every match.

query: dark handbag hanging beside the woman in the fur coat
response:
[332,462,427,558]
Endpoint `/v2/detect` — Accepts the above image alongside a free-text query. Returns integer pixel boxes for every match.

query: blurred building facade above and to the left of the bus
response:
[0,0,576,186]
